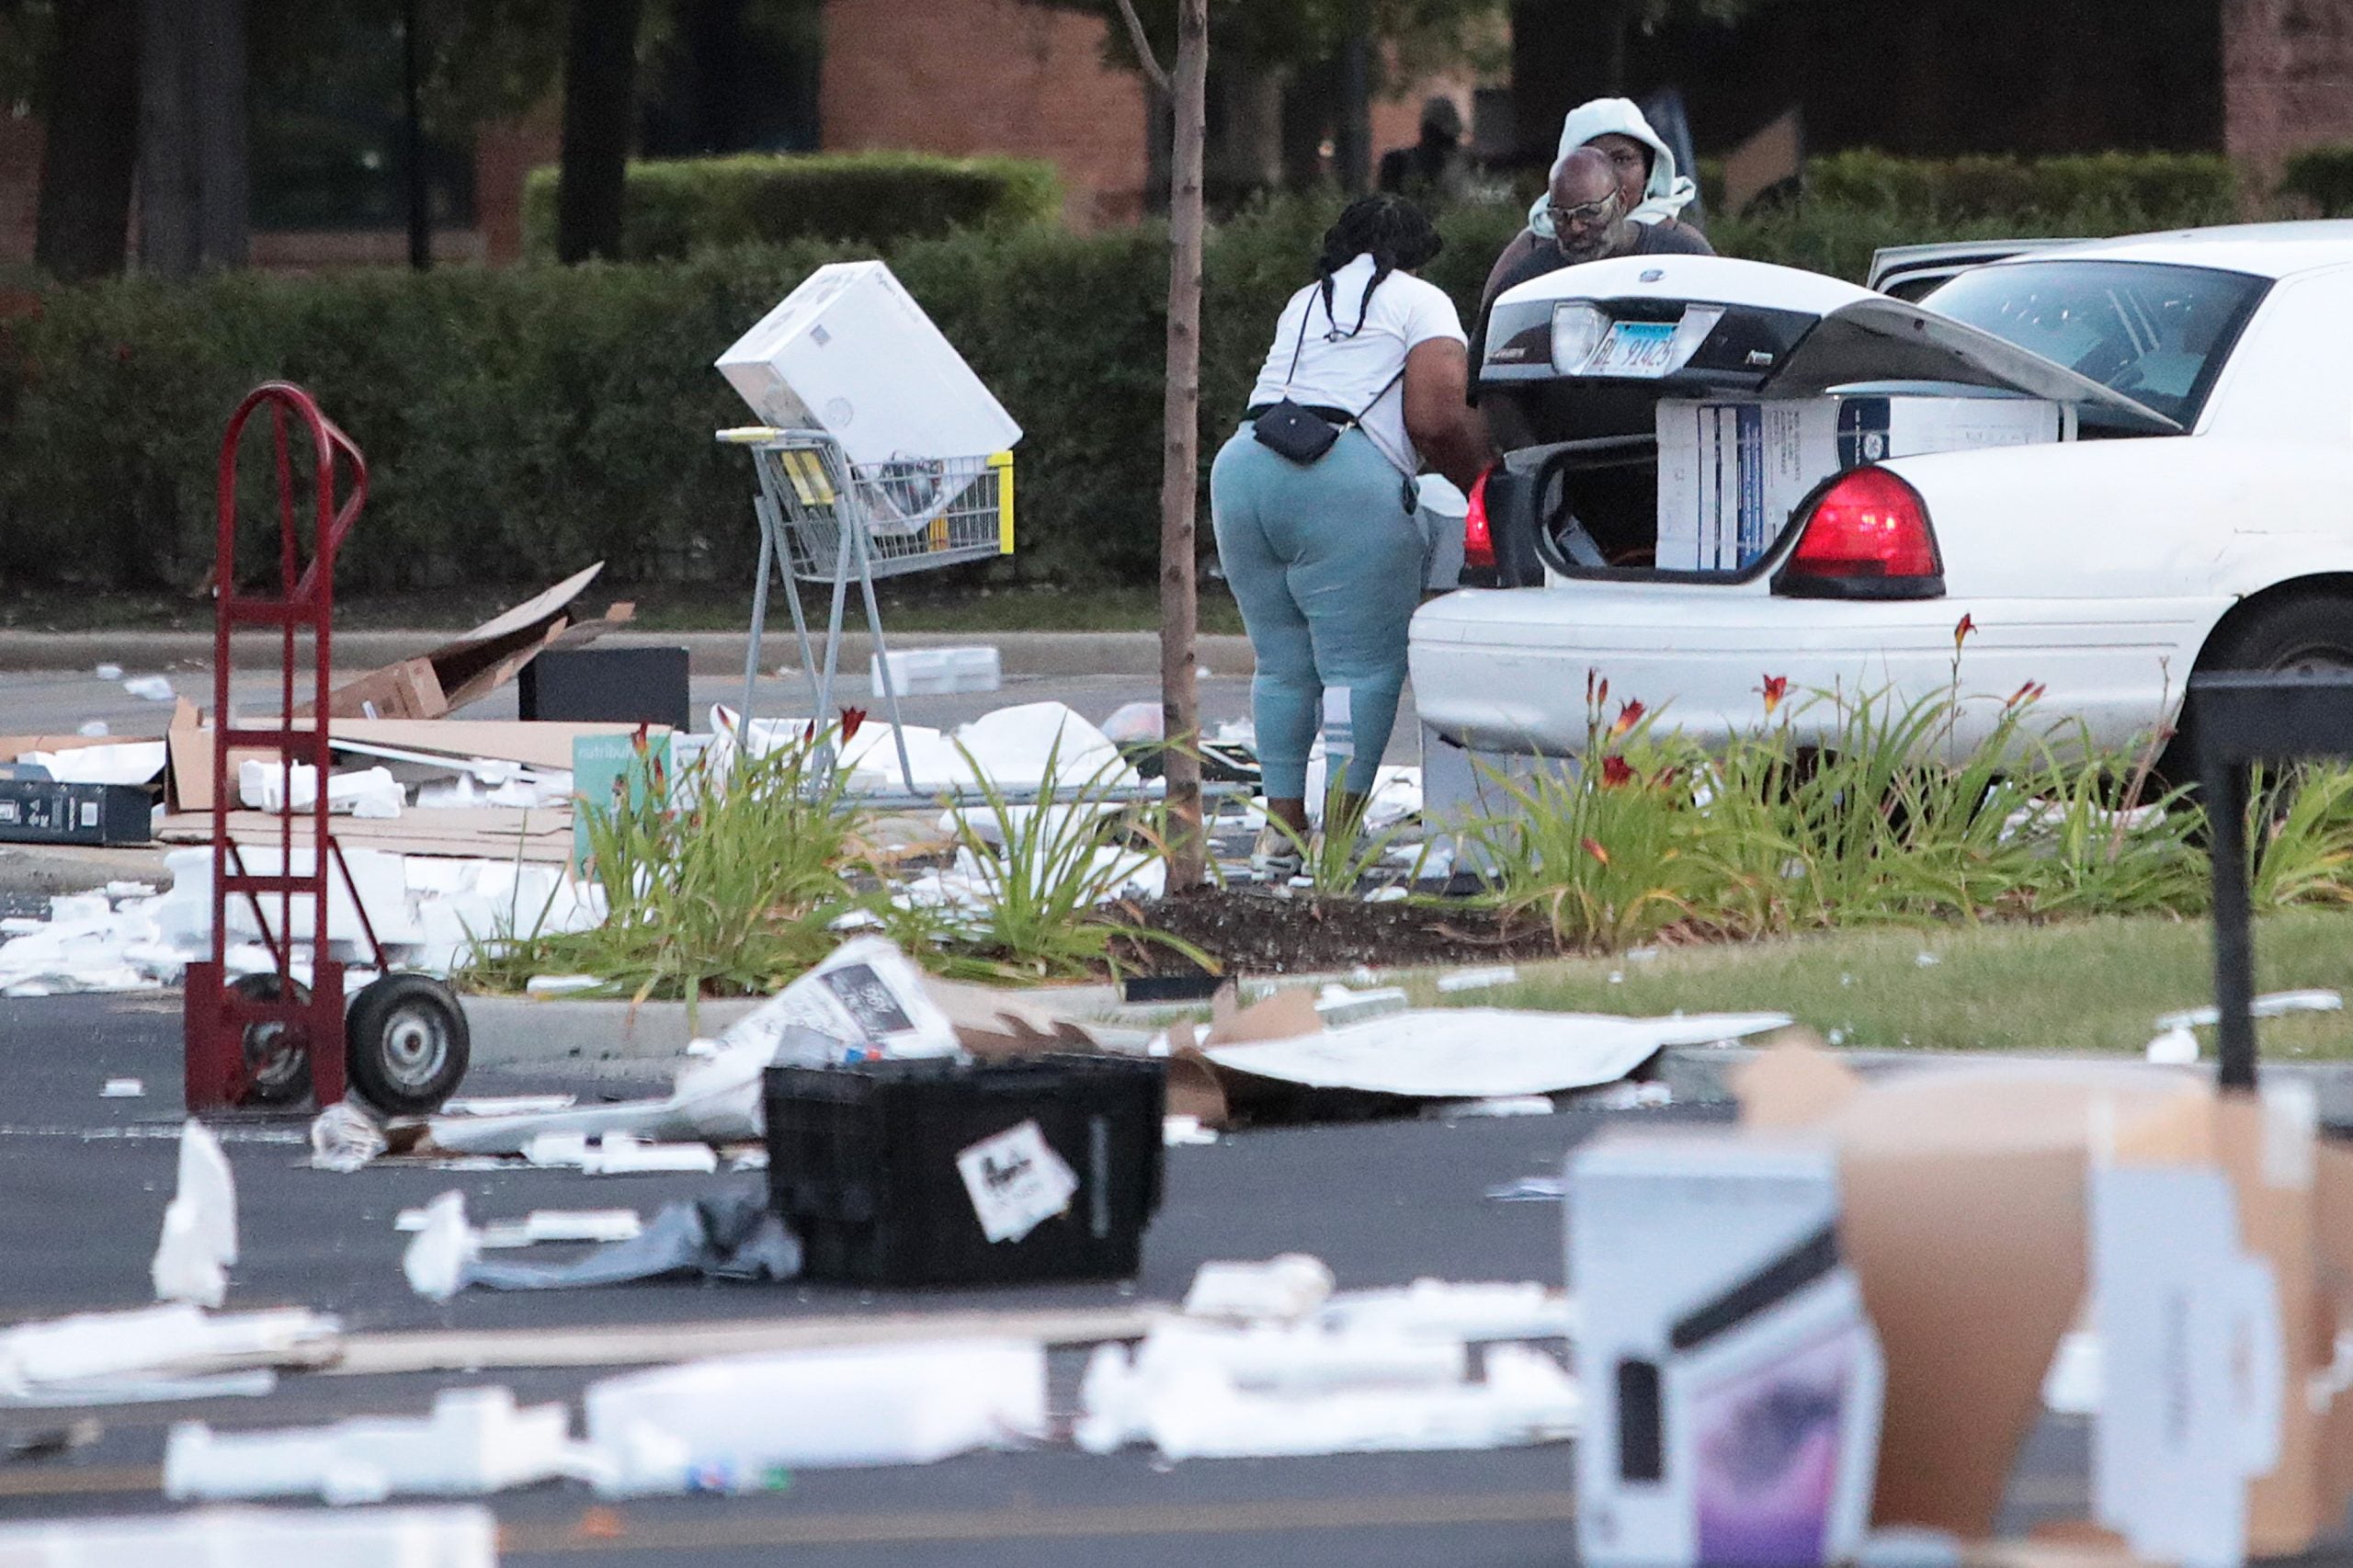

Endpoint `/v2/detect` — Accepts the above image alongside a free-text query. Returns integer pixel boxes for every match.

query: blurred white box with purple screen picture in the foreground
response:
[1567,1135,1885,1568]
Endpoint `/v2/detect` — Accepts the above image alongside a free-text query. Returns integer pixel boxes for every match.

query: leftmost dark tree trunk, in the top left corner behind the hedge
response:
[33,0,139,282]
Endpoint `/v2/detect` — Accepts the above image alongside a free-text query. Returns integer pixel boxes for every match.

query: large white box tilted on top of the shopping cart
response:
[718,261,1021,464]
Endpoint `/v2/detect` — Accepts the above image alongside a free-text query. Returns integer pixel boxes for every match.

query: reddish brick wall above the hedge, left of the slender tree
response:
[819,0,1146,226]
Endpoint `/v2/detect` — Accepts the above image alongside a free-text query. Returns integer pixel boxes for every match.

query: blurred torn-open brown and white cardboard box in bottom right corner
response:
[1570,1048,2353,1565]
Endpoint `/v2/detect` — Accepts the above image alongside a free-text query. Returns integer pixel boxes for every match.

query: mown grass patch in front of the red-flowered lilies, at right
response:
[1412,909,2353,1060]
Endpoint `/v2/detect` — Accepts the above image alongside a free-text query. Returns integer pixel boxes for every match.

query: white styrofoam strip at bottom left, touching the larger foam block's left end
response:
[163,1387,593,1505]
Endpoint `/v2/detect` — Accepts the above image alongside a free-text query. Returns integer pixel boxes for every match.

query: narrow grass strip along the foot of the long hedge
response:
[0,582,1243,633]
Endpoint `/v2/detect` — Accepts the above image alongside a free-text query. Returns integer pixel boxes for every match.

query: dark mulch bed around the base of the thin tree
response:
[1120,888,1560,974]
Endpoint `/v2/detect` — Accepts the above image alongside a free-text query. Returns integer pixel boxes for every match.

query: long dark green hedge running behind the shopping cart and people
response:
[0,179,2240,588]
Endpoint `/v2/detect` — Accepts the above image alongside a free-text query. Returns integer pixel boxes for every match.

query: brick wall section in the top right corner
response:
[2222,0,2353,190]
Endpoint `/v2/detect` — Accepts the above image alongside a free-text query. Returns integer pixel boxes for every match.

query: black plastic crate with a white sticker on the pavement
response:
[767,1055,1167,1286]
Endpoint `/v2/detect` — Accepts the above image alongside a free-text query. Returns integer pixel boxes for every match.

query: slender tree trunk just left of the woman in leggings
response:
[1160,0,1210,892]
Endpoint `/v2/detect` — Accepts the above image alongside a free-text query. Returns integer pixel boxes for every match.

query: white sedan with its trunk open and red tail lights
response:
[1412,223,2353,777]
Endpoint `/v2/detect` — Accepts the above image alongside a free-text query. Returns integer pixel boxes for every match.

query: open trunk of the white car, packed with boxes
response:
[1480,256,2181,586]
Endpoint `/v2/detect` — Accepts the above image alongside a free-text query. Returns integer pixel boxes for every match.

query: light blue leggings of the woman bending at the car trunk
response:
[1210,426,1428,801]
